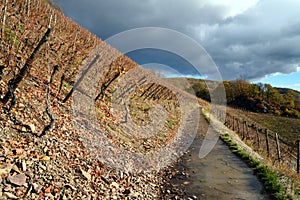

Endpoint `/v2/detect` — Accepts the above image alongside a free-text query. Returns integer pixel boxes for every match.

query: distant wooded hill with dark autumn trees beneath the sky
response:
[170,78,300,118]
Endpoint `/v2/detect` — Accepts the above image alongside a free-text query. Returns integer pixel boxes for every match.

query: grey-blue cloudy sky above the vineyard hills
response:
[55,0,300,91]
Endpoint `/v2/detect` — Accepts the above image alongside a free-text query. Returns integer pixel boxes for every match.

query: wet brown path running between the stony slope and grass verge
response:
[171,113,269,200]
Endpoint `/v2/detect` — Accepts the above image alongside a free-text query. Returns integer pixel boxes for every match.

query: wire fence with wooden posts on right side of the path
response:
[215,110,300,173]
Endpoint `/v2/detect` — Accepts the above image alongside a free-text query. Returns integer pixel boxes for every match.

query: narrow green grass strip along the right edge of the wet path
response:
[220,134,288,199]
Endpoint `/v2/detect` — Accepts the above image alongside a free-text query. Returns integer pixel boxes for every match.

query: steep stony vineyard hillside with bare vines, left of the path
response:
[0,0,199,199]
